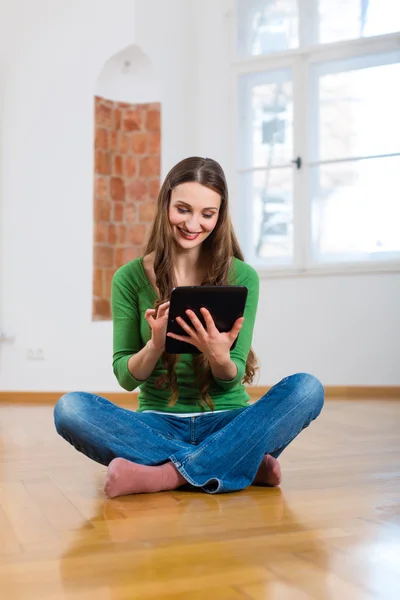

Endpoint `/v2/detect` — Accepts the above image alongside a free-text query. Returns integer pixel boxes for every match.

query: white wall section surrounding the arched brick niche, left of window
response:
[0,0,193,390]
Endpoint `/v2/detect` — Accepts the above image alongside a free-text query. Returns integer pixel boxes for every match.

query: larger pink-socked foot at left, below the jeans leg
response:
[104,458,187,498]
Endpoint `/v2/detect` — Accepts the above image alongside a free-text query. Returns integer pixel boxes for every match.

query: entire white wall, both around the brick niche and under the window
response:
[0,0,400,391]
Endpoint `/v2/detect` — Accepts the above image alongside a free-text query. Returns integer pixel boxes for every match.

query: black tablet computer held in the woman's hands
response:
[165,285,248,354]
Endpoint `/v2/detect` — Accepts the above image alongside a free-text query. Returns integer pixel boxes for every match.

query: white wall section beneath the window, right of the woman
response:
[254,274,400,385]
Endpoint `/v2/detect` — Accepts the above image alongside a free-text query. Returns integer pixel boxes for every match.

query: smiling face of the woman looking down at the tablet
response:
[168,181,221,250]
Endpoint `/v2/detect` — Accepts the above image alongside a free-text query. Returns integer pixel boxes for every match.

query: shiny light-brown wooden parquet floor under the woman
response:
[0,400,400,600]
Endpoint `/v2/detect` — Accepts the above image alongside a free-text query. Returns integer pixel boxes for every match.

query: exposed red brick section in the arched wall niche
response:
[93,97,160,320]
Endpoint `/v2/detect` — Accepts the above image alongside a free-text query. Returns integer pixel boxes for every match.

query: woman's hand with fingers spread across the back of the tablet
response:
[168,308,244,365]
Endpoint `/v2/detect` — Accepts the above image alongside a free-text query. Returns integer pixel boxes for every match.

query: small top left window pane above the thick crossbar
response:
[236,0,298,56]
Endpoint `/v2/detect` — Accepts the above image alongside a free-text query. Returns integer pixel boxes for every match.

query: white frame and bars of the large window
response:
[229,0,400,277]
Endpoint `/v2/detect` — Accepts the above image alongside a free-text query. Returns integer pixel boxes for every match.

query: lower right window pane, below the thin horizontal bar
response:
[312,156,400,260]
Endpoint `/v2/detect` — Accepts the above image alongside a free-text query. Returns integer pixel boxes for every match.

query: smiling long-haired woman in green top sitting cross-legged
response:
[55,157,324,498]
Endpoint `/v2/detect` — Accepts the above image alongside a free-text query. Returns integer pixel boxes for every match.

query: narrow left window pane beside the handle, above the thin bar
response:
[239,69,293,168]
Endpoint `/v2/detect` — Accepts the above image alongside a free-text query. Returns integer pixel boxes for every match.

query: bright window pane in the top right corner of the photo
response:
[318,0,400,44]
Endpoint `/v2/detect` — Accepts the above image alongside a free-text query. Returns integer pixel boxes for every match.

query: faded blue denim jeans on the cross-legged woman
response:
[54,373,324,494]
